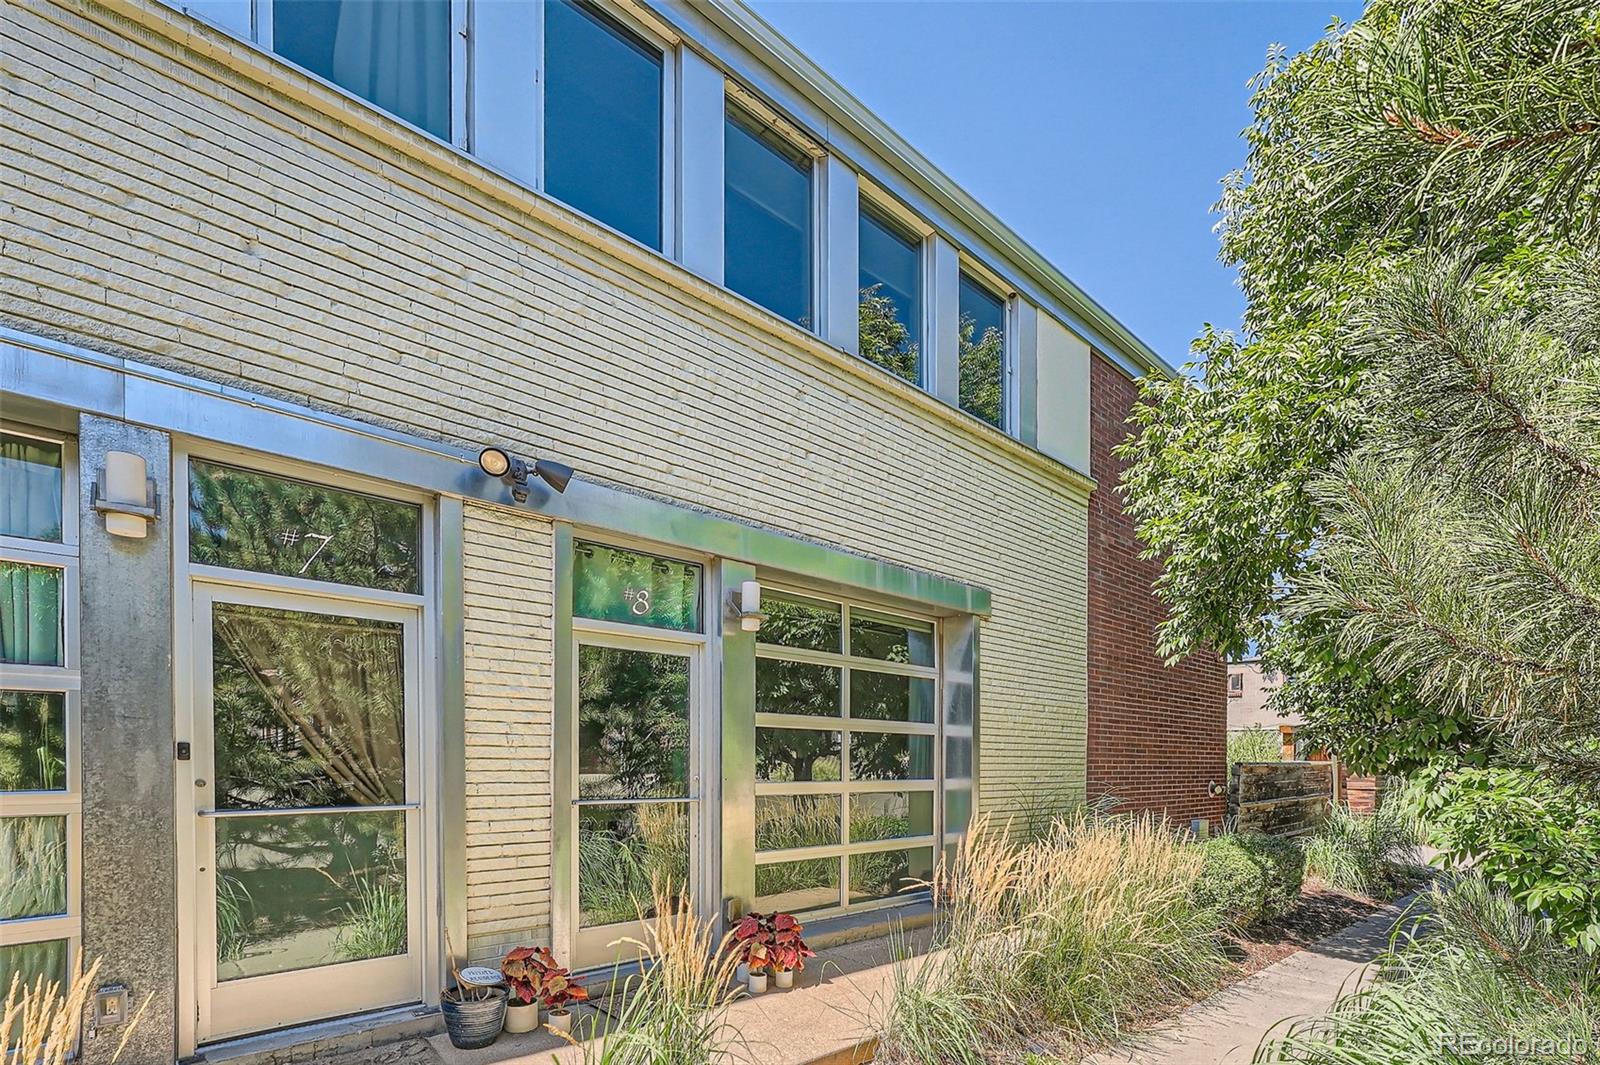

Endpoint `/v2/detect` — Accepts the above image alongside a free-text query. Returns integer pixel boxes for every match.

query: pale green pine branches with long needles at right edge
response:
[1290,256,1600,783]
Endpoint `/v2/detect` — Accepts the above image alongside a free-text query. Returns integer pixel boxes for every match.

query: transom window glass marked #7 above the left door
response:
[189,459,422,593]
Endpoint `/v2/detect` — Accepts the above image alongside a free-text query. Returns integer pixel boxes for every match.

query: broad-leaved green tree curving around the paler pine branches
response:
[1122,0,1600,766]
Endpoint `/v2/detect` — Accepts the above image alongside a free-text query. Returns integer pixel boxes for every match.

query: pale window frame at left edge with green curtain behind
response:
[0,424,83,980]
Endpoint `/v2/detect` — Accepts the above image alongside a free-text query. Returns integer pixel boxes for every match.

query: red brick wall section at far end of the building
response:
[1088,355,1227,832]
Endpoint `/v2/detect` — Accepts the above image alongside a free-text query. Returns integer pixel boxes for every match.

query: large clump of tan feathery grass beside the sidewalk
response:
[874,814,1226,1065]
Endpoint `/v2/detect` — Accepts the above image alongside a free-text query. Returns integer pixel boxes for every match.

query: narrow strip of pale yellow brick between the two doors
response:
[462,504,555,963]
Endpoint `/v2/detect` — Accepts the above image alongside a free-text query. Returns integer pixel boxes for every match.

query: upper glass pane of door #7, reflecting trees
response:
[211,603,405,809]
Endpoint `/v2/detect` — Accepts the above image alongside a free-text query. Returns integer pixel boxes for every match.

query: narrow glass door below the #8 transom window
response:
[570,633,701,967]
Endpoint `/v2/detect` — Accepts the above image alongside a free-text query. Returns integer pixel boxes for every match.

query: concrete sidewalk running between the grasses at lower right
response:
[1083,895,1414,1065]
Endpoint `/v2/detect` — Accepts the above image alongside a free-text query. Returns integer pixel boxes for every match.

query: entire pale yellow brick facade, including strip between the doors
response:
[0,0,1088,942]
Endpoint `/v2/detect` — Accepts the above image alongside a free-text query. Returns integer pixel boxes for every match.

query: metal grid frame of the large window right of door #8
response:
[752,582,940,919]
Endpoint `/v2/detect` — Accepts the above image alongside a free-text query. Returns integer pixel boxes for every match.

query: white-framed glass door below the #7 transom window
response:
[192,582,424,1041]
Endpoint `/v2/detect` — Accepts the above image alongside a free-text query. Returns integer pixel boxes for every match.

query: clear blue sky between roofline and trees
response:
[754,0,1360,363]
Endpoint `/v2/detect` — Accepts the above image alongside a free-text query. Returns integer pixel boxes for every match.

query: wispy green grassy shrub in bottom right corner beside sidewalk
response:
[1254,873,1600,1065]
